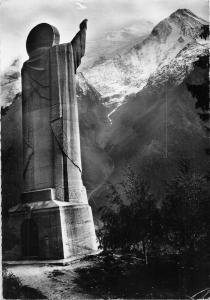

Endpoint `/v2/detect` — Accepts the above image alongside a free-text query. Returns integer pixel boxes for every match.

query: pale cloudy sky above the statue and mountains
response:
[0,0,208,72]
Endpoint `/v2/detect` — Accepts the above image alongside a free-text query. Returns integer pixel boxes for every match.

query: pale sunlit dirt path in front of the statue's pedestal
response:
[8,262,102,300]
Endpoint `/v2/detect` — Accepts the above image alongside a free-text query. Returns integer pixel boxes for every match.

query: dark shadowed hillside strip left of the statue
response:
[1,94,23,216]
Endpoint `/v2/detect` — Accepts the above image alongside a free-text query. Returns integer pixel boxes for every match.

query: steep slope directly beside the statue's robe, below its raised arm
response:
[77,74,112,194]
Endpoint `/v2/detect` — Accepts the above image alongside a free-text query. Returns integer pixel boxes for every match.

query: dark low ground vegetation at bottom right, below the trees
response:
[74,251,209,299]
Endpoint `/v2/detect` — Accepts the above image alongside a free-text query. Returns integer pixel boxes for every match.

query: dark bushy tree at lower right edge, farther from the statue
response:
[162,159,210,263]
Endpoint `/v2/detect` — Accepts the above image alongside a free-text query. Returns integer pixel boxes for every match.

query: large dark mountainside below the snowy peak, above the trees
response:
[89,51,210,208]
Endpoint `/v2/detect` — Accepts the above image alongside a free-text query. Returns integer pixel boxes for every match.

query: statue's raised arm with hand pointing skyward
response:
[71,19,87,73]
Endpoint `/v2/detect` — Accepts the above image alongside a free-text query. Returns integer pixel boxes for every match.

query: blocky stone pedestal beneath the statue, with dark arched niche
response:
[3,200,97,260]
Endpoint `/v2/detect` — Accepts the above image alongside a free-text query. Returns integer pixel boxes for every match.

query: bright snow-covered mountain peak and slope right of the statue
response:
[82,9,208,115]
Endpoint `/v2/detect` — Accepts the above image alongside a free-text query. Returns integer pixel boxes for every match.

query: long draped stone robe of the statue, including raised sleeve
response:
[22,28,87,203]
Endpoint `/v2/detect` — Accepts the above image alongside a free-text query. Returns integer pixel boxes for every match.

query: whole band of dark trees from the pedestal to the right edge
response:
[98,160,210,265]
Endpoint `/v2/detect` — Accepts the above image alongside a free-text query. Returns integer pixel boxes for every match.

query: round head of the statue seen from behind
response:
[26,23,60,56]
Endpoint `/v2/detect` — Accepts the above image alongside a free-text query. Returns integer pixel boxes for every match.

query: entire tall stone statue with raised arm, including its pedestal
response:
[5,20,97,259]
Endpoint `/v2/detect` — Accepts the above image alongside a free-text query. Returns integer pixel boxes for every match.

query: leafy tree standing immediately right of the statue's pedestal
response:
[98,166,161,263]
